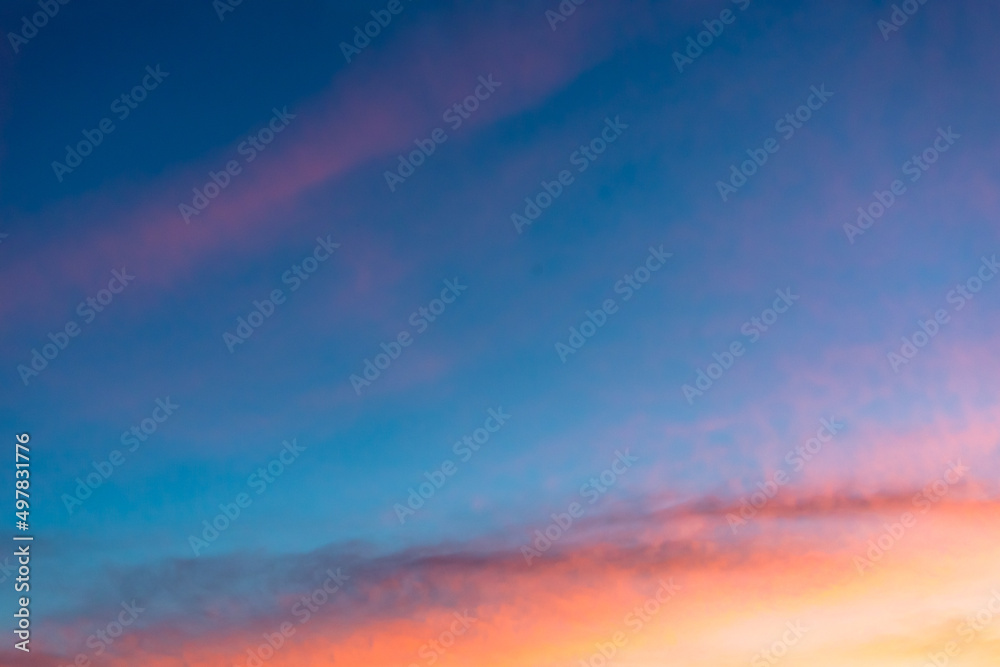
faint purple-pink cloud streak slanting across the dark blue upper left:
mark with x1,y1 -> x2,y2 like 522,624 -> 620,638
0,0 -> 641,330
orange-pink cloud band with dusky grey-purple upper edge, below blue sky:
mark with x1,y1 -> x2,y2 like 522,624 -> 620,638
25,480 -> 1000,665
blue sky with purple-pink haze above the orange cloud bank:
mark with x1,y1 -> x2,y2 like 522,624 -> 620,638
0,1 -> 1000,665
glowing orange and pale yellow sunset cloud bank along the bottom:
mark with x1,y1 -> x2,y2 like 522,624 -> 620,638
17,493 -> 1000,667
